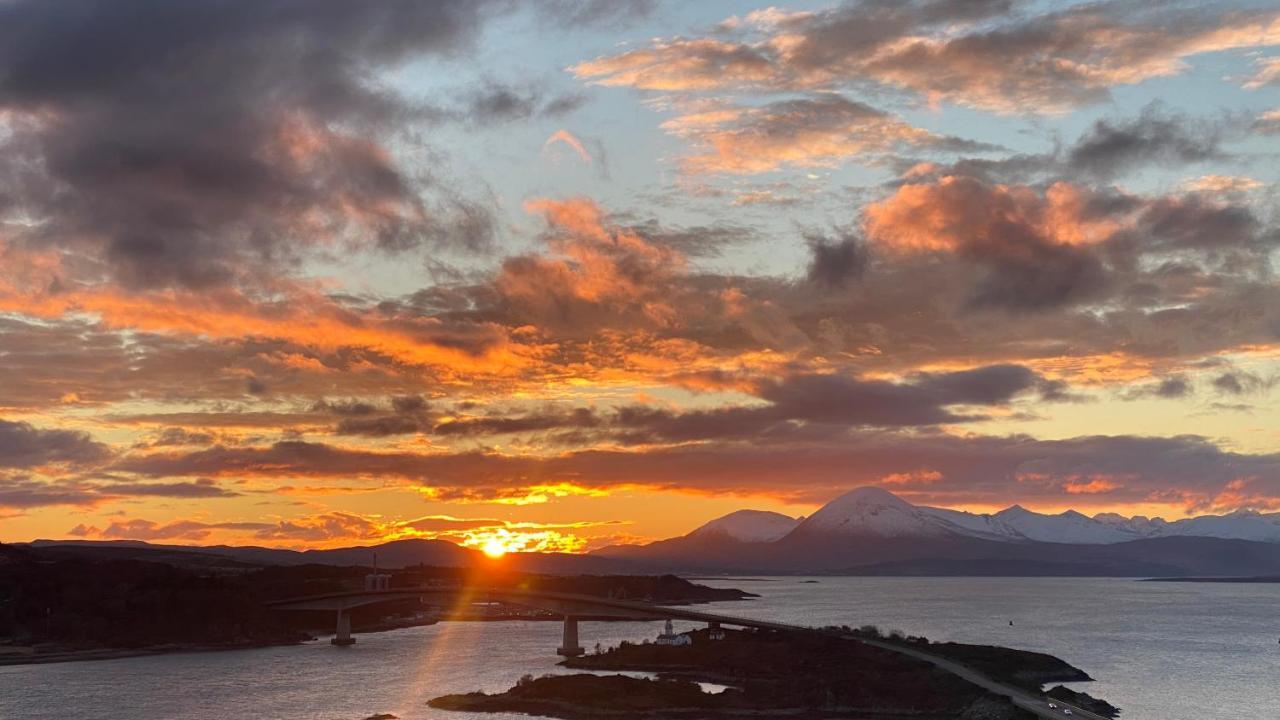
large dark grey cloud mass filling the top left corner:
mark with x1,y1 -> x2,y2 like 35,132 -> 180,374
0,0 -> 509,287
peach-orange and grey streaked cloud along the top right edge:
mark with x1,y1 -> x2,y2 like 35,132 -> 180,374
570,3 -> 1280,113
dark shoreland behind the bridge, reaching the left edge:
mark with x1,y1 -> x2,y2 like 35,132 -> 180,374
0,544 -> 749,665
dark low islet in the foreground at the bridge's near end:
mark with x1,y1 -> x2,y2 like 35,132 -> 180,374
430,630 -> 1111,720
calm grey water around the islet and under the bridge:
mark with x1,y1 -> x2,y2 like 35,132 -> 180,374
0,578 -> 1280,720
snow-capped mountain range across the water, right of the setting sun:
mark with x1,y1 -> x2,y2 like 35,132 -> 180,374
594,487 -> 1280,577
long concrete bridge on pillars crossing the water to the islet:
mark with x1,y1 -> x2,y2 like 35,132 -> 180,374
268,587 -> 813,656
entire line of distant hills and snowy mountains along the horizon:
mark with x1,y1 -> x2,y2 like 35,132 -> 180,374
22,487 -> 1280,577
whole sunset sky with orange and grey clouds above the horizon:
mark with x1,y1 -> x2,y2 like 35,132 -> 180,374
0,0 -> 1280,552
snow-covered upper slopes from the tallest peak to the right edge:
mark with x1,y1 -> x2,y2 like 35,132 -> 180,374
778,487 -> 1280,544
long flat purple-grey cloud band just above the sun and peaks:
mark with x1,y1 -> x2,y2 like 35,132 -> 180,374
104,432 -> 1280,510
